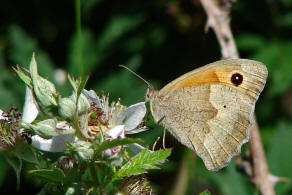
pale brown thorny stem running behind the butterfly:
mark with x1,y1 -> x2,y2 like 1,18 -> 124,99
201,0 -> 275,195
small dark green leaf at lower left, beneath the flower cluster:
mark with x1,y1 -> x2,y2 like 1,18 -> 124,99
29,168 -> 65,184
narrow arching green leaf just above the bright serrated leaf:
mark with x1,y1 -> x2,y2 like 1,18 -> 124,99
94,138 -> 145,154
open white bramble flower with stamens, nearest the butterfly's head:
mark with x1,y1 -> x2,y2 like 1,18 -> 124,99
83,90 -> 147,156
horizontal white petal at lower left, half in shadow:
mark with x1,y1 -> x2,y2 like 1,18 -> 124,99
31,135 -> 75,152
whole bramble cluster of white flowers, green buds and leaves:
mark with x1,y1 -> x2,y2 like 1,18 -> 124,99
0,55 -> 170,194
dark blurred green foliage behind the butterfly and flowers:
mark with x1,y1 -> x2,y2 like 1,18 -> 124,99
0,0 -> 292,195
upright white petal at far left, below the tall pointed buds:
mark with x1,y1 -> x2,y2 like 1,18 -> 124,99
22,86 -> 39,123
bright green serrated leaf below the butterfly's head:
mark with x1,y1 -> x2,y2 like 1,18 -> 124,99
113,149 -> 171,180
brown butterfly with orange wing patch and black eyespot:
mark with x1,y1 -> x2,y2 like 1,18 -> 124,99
146,59 -> 268,171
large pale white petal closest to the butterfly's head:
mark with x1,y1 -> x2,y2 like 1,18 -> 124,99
117,102 -> 146,134
